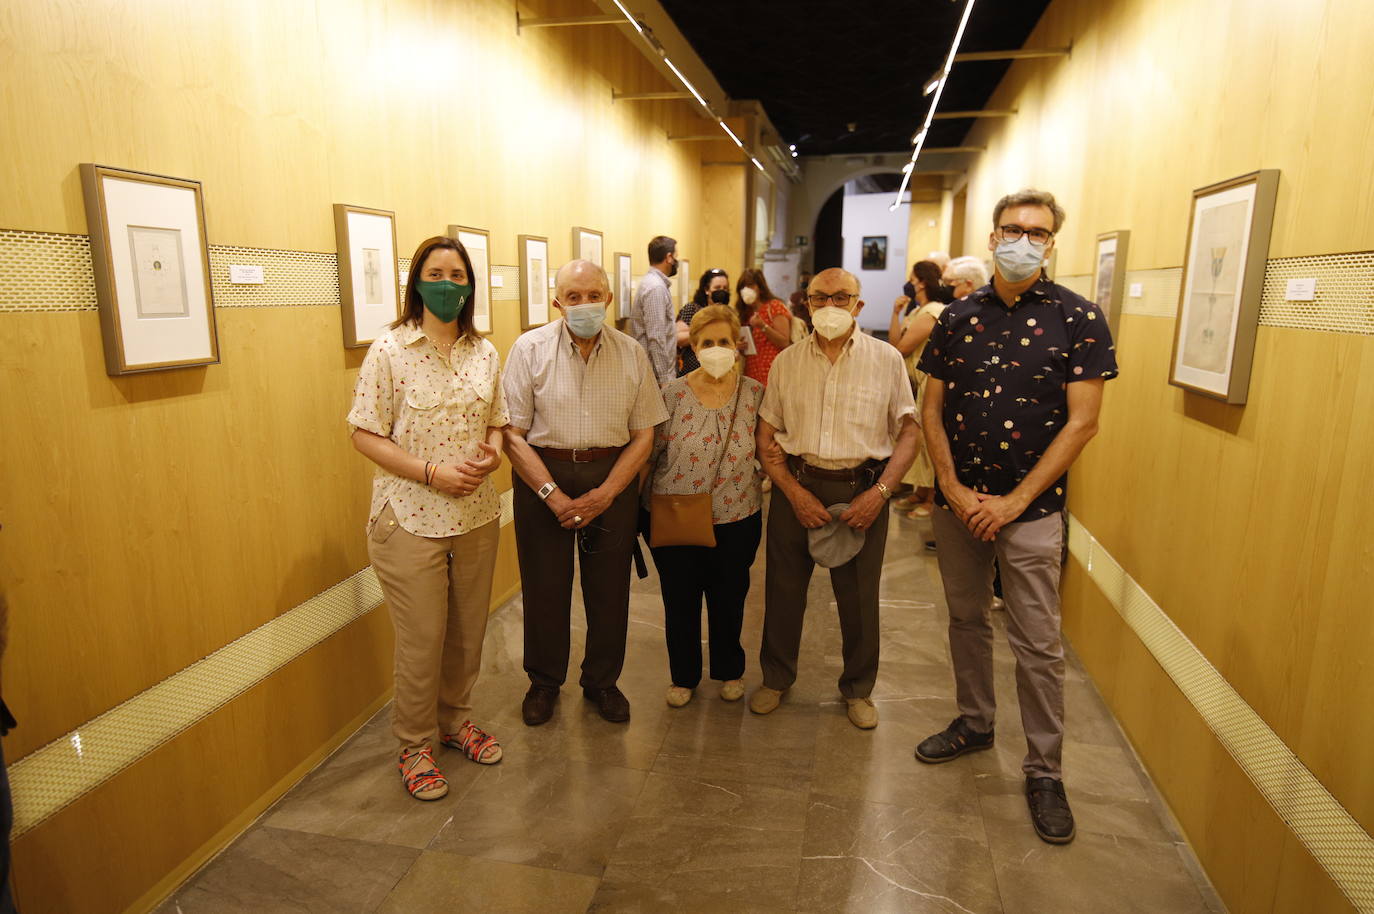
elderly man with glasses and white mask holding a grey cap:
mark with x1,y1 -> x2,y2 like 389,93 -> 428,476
749,269 -> 918,730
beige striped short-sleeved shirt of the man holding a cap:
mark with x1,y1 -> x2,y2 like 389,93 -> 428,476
758,328 -> 916,470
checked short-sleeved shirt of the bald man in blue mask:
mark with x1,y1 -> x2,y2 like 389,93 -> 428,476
504,319 -> 668,449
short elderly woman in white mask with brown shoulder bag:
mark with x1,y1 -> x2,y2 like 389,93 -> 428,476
647,305 -> 764,708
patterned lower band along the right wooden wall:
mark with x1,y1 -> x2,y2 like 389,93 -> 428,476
1069,517 -> 1374,911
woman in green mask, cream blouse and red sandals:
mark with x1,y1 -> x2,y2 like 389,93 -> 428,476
348,236 -> 508,800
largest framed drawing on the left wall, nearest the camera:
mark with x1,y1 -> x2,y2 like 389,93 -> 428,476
81,162 -> 220,375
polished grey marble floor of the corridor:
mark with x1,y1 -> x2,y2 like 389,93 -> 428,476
159,505 -> 1223,914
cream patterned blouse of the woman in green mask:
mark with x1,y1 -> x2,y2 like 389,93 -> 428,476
348,324 -> 510,536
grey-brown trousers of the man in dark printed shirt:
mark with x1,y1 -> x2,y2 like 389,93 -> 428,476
932,509 -> 1063,778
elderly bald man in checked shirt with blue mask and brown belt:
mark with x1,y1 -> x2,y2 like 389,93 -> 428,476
504,260 -> 668,727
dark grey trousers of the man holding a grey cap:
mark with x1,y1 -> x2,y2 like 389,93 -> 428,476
758,474 -> 888,698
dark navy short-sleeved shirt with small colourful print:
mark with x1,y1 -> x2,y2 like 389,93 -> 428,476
918,278 -> 1117,522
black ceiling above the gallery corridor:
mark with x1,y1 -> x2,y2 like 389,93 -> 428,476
660,0 -> 1048,155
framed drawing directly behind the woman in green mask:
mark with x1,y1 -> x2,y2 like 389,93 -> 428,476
334,203 -> 401,349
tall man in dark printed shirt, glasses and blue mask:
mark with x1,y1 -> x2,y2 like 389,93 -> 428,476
916,190 -> 1117,844
